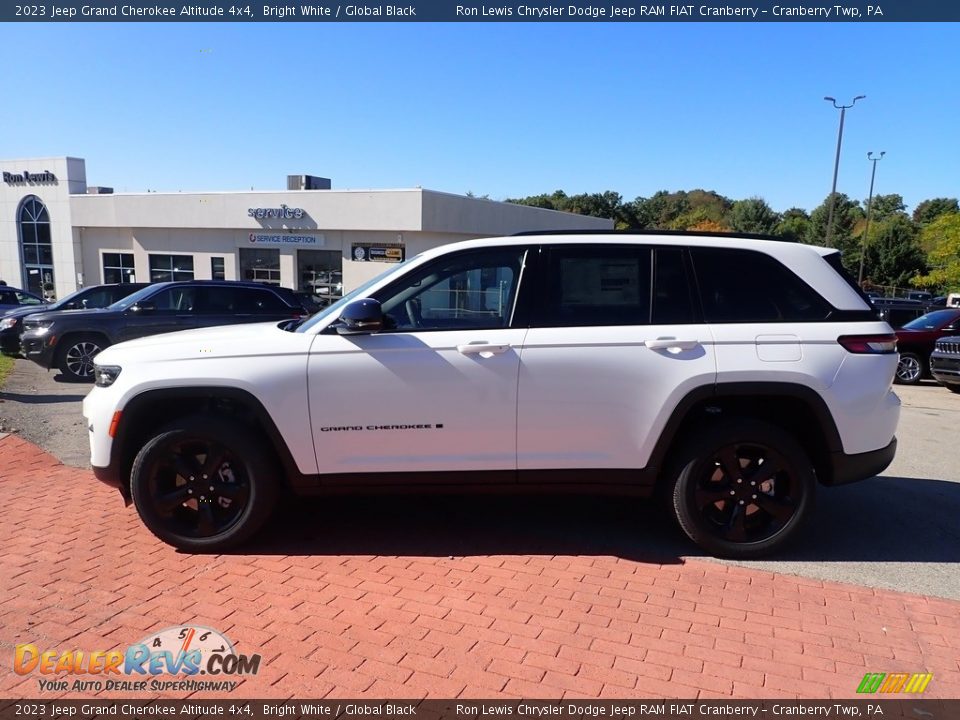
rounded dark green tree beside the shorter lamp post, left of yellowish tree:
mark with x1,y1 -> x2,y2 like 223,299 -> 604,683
860,215 -> 927,287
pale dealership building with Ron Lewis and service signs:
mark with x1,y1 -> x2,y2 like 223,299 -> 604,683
0,157 -> 613,298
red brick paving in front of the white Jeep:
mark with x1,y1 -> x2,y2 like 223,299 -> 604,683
0,436 -> 960,698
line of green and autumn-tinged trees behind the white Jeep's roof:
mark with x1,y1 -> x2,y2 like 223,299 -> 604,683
506,190 -> 960,294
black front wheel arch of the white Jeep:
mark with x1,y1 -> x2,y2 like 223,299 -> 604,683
110,386 -> 301,500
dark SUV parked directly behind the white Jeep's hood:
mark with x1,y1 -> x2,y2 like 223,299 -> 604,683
21,280 -> 309,382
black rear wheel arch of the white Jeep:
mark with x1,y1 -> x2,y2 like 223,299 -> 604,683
648,382 -> 843,485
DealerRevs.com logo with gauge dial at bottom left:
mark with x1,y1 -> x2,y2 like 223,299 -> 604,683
13,625 -> 261,692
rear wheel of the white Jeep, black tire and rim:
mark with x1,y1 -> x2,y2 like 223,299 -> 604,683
668,419 -> 817,559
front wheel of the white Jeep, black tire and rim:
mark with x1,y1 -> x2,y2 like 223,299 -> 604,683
130,415 -> 277,552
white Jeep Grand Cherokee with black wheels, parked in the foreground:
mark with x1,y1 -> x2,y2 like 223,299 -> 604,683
83,233 -> 900,557
